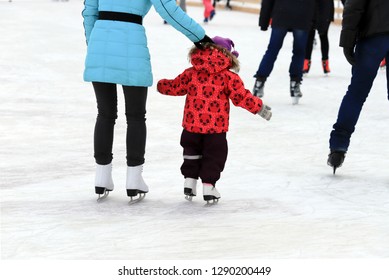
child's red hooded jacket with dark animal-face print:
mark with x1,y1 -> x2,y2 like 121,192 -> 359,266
157,48 -> 262,134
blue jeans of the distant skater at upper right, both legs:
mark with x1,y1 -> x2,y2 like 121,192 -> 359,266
255,28 -> 308,81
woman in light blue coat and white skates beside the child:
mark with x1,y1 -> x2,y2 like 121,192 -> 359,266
82,0 -> 212,199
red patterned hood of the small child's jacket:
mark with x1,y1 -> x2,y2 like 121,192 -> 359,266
190,48 -> 232,73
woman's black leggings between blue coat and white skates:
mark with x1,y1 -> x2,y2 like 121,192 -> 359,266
92,82 -> 147,166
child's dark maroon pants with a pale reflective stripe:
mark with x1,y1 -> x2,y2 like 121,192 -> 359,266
180,129 -> 228,185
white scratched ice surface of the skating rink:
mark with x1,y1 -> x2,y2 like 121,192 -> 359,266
0,0 -> 389,260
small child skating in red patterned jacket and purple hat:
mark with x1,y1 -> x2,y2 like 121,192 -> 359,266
157,37 -> 272,202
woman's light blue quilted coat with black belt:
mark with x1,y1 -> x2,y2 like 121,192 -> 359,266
82,0 -> 205,87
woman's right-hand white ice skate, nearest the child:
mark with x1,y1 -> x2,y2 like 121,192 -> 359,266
126,165 -> 149,203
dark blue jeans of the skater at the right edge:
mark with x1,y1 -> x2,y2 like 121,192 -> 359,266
330,35 -> 389,152
